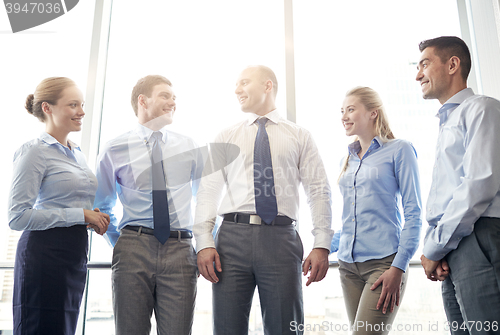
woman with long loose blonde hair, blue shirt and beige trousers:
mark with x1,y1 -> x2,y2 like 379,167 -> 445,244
332,87 -> 422,334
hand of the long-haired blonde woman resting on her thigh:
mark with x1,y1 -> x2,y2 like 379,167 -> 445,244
370,266 -> 403,314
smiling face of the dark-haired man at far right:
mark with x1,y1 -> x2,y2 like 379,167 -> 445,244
415,47 -> 454,104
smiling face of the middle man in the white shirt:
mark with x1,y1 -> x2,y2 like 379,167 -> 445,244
234,68 -> 272,115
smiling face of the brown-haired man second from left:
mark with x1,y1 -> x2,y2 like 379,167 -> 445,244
137,84 -> 176,129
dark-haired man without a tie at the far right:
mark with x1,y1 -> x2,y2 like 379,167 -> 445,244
416,37 -> 500,334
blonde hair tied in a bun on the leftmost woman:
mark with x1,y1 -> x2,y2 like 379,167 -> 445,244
24,77 -> 76,122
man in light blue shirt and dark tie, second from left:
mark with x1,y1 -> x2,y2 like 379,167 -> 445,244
95,76 -> 203,335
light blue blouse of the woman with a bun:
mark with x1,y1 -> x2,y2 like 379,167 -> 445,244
9,133 -> 97,230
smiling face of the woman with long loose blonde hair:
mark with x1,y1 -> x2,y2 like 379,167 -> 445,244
341,95 -> 377,140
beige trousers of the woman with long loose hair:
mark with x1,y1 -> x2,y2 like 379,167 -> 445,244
339,254 -> 408,335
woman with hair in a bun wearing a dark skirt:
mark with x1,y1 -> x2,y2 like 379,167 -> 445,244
9,77 -> 109,335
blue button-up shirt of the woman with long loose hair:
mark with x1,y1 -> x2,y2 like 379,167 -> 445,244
334,136 -> 422,271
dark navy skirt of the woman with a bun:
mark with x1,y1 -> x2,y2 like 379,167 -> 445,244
13,225 -> 88,335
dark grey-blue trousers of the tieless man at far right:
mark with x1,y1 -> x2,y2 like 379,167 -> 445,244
442,218 -> 500,335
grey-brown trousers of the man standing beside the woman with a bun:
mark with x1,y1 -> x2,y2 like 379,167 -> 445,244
111,229 -> 198,335
